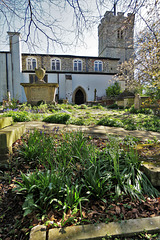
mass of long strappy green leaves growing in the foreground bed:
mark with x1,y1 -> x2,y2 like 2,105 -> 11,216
14,129 -> 158,220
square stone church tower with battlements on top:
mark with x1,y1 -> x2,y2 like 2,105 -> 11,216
98,11 -> 134,63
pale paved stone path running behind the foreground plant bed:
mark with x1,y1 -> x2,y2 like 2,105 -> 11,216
25,121 -> 160,141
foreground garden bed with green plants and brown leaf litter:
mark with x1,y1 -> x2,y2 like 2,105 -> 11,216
0,128 -> 160,240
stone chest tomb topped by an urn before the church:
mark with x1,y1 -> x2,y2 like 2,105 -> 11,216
21,68 -> 58,105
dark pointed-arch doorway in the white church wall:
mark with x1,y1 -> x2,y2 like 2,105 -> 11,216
72,86 -> 87,105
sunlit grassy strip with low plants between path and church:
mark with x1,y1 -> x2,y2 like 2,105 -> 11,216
3,104 -> 160,132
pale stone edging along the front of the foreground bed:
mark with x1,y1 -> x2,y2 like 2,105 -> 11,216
30,216 -> 160,240
